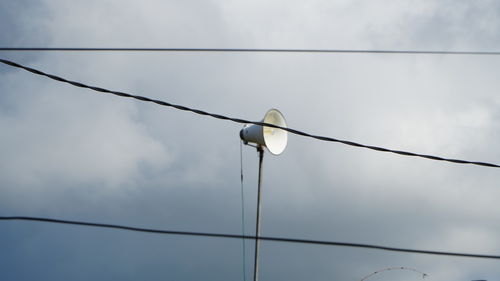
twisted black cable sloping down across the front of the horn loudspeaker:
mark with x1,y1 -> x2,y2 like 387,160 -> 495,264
0,56 -> 500,168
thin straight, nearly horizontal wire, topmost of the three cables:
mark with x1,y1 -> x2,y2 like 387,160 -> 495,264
0,47 -> 500,56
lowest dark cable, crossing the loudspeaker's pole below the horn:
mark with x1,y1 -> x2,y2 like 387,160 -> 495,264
0,216 -> 500,260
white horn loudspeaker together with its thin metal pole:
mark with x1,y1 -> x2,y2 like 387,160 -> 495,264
240,109 -> 288,281
